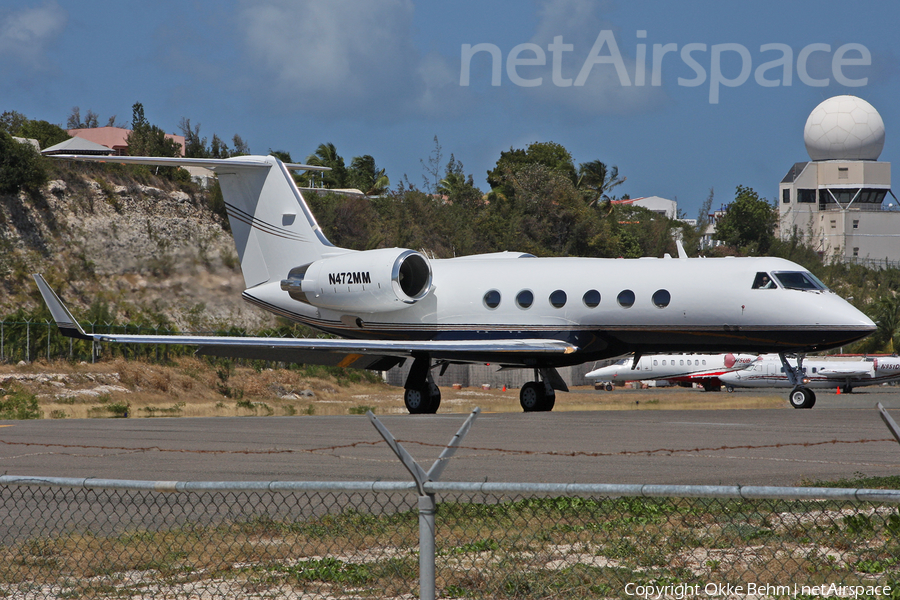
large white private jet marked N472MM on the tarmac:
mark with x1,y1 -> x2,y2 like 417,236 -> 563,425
35,156 -> 875,413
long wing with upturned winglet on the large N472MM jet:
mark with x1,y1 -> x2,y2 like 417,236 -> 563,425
34,274 -> 577,370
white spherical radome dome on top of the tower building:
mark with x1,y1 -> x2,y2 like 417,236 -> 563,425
803,96 -> 884,160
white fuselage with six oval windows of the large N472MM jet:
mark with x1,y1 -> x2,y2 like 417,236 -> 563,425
244,253 -> 874,364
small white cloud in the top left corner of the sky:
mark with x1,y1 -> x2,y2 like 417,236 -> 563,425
0,1 -> 69,69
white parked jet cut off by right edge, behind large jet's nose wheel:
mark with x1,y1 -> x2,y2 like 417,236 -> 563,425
719,354 -> 900,408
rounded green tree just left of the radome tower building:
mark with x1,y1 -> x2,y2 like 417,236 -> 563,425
716,185 -> 778,254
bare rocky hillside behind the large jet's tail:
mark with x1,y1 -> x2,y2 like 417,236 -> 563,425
0,161 -> 273,330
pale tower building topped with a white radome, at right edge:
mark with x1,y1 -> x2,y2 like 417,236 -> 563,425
778,96 -> 900,265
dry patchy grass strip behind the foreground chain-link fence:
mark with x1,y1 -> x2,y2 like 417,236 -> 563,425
0,495 -> 900,599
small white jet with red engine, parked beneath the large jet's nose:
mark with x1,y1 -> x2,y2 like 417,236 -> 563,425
585,353 -> 758,392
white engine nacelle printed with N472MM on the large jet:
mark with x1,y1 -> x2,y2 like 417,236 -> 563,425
281,248 -> 432,313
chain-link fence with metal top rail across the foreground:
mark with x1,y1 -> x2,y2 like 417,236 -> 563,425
0,476 -> 900,600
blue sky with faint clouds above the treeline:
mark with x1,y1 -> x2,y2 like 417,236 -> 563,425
0,0 -> 900,217
